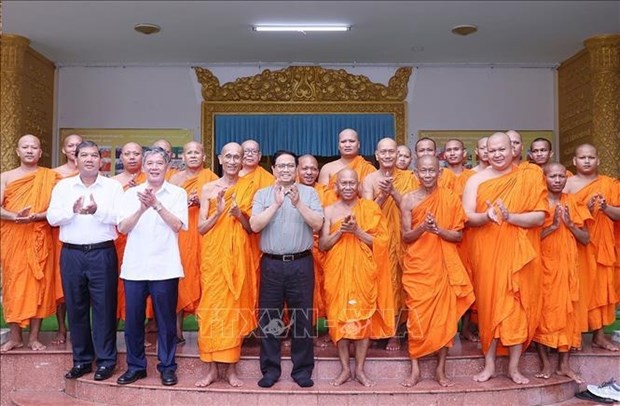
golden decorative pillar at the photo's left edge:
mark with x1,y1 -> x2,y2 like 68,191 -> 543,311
0,34 -> 56,172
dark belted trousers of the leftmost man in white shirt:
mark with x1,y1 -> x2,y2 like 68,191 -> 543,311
60,246 -> 118,367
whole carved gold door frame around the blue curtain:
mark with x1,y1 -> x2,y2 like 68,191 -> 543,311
194,66 -> 411,167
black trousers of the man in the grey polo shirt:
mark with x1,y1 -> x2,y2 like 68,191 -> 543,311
259,255 -> 314,379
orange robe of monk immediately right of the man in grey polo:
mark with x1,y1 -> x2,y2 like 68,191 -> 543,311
325,199 -> 395,343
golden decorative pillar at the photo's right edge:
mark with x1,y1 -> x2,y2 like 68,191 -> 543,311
584,34 -> 620,178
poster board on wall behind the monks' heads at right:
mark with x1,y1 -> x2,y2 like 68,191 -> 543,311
418,130 -> 557,168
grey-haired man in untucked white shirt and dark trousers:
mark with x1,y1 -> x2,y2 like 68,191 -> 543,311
117,147 -> 188,386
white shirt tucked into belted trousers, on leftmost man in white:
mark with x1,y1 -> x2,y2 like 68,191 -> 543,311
47,175 -> 123,244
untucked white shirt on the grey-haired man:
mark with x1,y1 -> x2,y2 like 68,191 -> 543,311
117,182 -> 188,281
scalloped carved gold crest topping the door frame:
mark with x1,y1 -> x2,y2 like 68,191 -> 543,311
194,66 -> 411,102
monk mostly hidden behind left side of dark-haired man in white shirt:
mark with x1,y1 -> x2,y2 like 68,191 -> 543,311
52,134 -> 82,344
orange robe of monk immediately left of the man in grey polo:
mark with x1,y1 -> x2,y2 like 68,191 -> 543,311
196,178 -> 257,363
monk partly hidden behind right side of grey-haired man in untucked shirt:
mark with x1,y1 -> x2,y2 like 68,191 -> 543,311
170,141 -> 217,344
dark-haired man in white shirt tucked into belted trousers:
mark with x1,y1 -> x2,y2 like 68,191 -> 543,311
47,141 -> 123,381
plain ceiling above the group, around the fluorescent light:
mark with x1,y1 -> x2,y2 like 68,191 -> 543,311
2,0 -> 620,66
